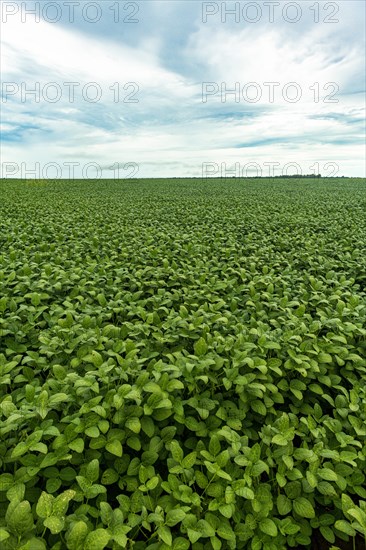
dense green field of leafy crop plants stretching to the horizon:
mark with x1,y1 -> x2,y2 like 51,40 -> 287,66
0,179 -> 366,550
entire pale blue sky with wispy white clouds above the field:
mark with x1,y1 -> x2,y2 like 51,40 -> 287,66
1,0 -> 366,178
